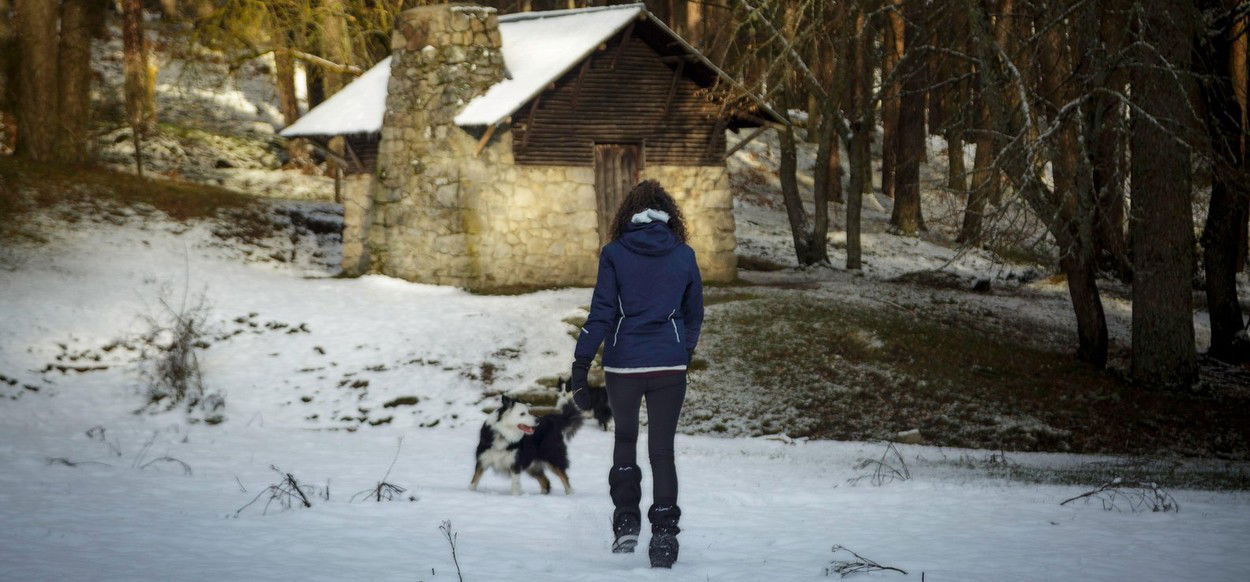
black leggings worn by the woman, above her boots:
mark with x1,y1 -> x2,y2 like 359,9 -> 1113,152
606,372 -> 686,505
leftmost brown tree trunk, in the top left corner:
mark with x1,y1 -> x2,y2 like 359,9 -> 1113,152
14,0 -> 60,161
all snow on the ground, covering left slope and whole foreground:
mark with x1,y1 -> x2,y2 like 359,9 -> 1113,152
0,201 -> 1250,581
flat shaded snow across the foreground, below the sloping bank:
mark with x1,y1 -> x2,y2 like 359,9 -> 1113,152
0,418 -> 1250,581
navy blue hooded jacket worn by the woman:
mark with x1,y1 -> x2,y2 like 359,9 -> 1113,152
574,216 -> 703,370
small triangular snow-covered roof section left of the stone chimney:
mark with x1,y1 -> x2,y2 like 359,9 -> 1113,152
280,56 -> 391,137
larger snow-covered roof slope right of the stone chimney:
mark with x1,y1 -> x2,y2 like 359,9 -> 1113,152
455,4 -> 645,125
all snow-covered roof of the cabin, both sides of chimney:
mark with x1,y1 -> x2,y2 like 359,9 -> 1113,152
280,4 -> 771,137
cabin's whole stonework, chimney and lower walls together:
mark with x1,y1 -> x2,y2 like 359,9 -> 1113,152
344,5 -> 736,290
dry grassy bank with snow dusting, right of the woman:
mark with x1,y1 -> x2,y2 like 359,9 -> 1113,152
686,291 -> 1250,460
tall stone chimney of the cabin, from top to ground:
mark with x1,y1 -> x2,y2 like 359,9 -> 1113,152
365,4 -> 504,285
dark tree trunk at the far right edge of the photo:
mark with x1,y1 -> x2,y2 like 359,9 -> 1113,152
1195,0 -> 1250,362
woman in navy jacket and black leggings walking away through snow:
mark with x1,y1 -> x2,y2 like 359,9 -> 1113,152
569,180 -> 703,568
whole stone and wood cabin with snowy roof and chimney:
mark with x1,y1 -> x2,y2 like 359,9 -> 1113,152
281,4 -> 780,290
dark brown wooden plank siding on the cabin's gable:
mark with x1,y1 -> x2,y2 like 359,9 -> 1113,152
513,32 -> 725,166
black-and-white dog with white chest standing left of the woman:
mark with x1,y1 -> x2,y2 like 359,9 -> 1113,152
469,383 -> 583,495
